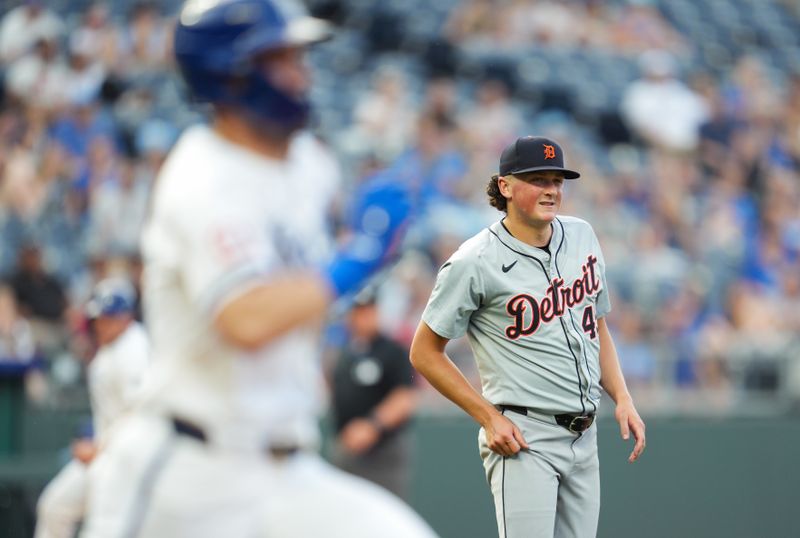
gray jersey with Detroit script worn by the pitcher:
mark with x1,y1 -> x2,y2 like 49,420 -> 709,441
422,216 -> 611,414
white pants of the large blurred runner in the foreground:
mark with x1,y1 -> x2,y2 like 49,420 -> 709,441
82,417 -> 435,538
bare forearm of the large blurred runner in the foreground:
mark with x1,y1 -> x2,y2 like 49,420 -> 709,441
215,273 -> 333,350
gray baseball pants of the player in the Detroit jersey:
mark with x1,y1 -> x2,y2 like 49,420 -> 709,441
478,411 -> 600,538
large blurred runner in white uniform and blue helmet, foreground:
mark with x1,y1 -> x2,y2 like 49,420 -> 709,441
84,0 -> 434,538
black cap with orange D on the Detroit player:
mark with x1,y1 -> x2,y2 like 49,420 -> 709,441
500,136 -> 581,179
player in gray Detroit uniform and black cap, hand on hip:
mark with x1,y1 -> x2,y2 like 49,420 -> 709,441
411,137 -> 645,538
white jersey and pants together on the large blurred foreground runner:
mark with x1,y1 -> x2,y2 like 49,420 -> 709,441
83,127 -> 434,538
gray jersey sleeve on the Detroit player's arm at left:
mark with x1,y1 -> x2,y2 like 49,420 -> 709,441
422,252 -> 484,340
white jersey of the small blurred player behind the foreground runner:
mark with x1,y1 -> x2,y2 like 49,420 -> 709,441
88,321 -> 150,446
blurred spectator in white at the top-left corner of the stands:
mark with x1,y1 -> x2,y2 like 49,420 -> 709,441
0,0 -> 64,64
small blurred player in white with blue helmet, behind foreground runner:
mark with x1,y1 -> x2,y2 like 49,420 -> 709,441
35,279 -> 149,538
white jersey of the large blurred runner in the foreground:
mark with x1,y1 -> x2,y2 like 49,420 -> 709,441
143,126 -> 339,447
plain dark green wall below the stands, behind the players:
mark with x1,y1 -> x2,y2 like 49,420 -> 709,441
0,413 -> 800,538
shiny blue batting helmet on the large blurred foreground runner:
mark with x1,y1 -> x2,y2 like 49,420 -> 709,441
174,0 -> 329,131
